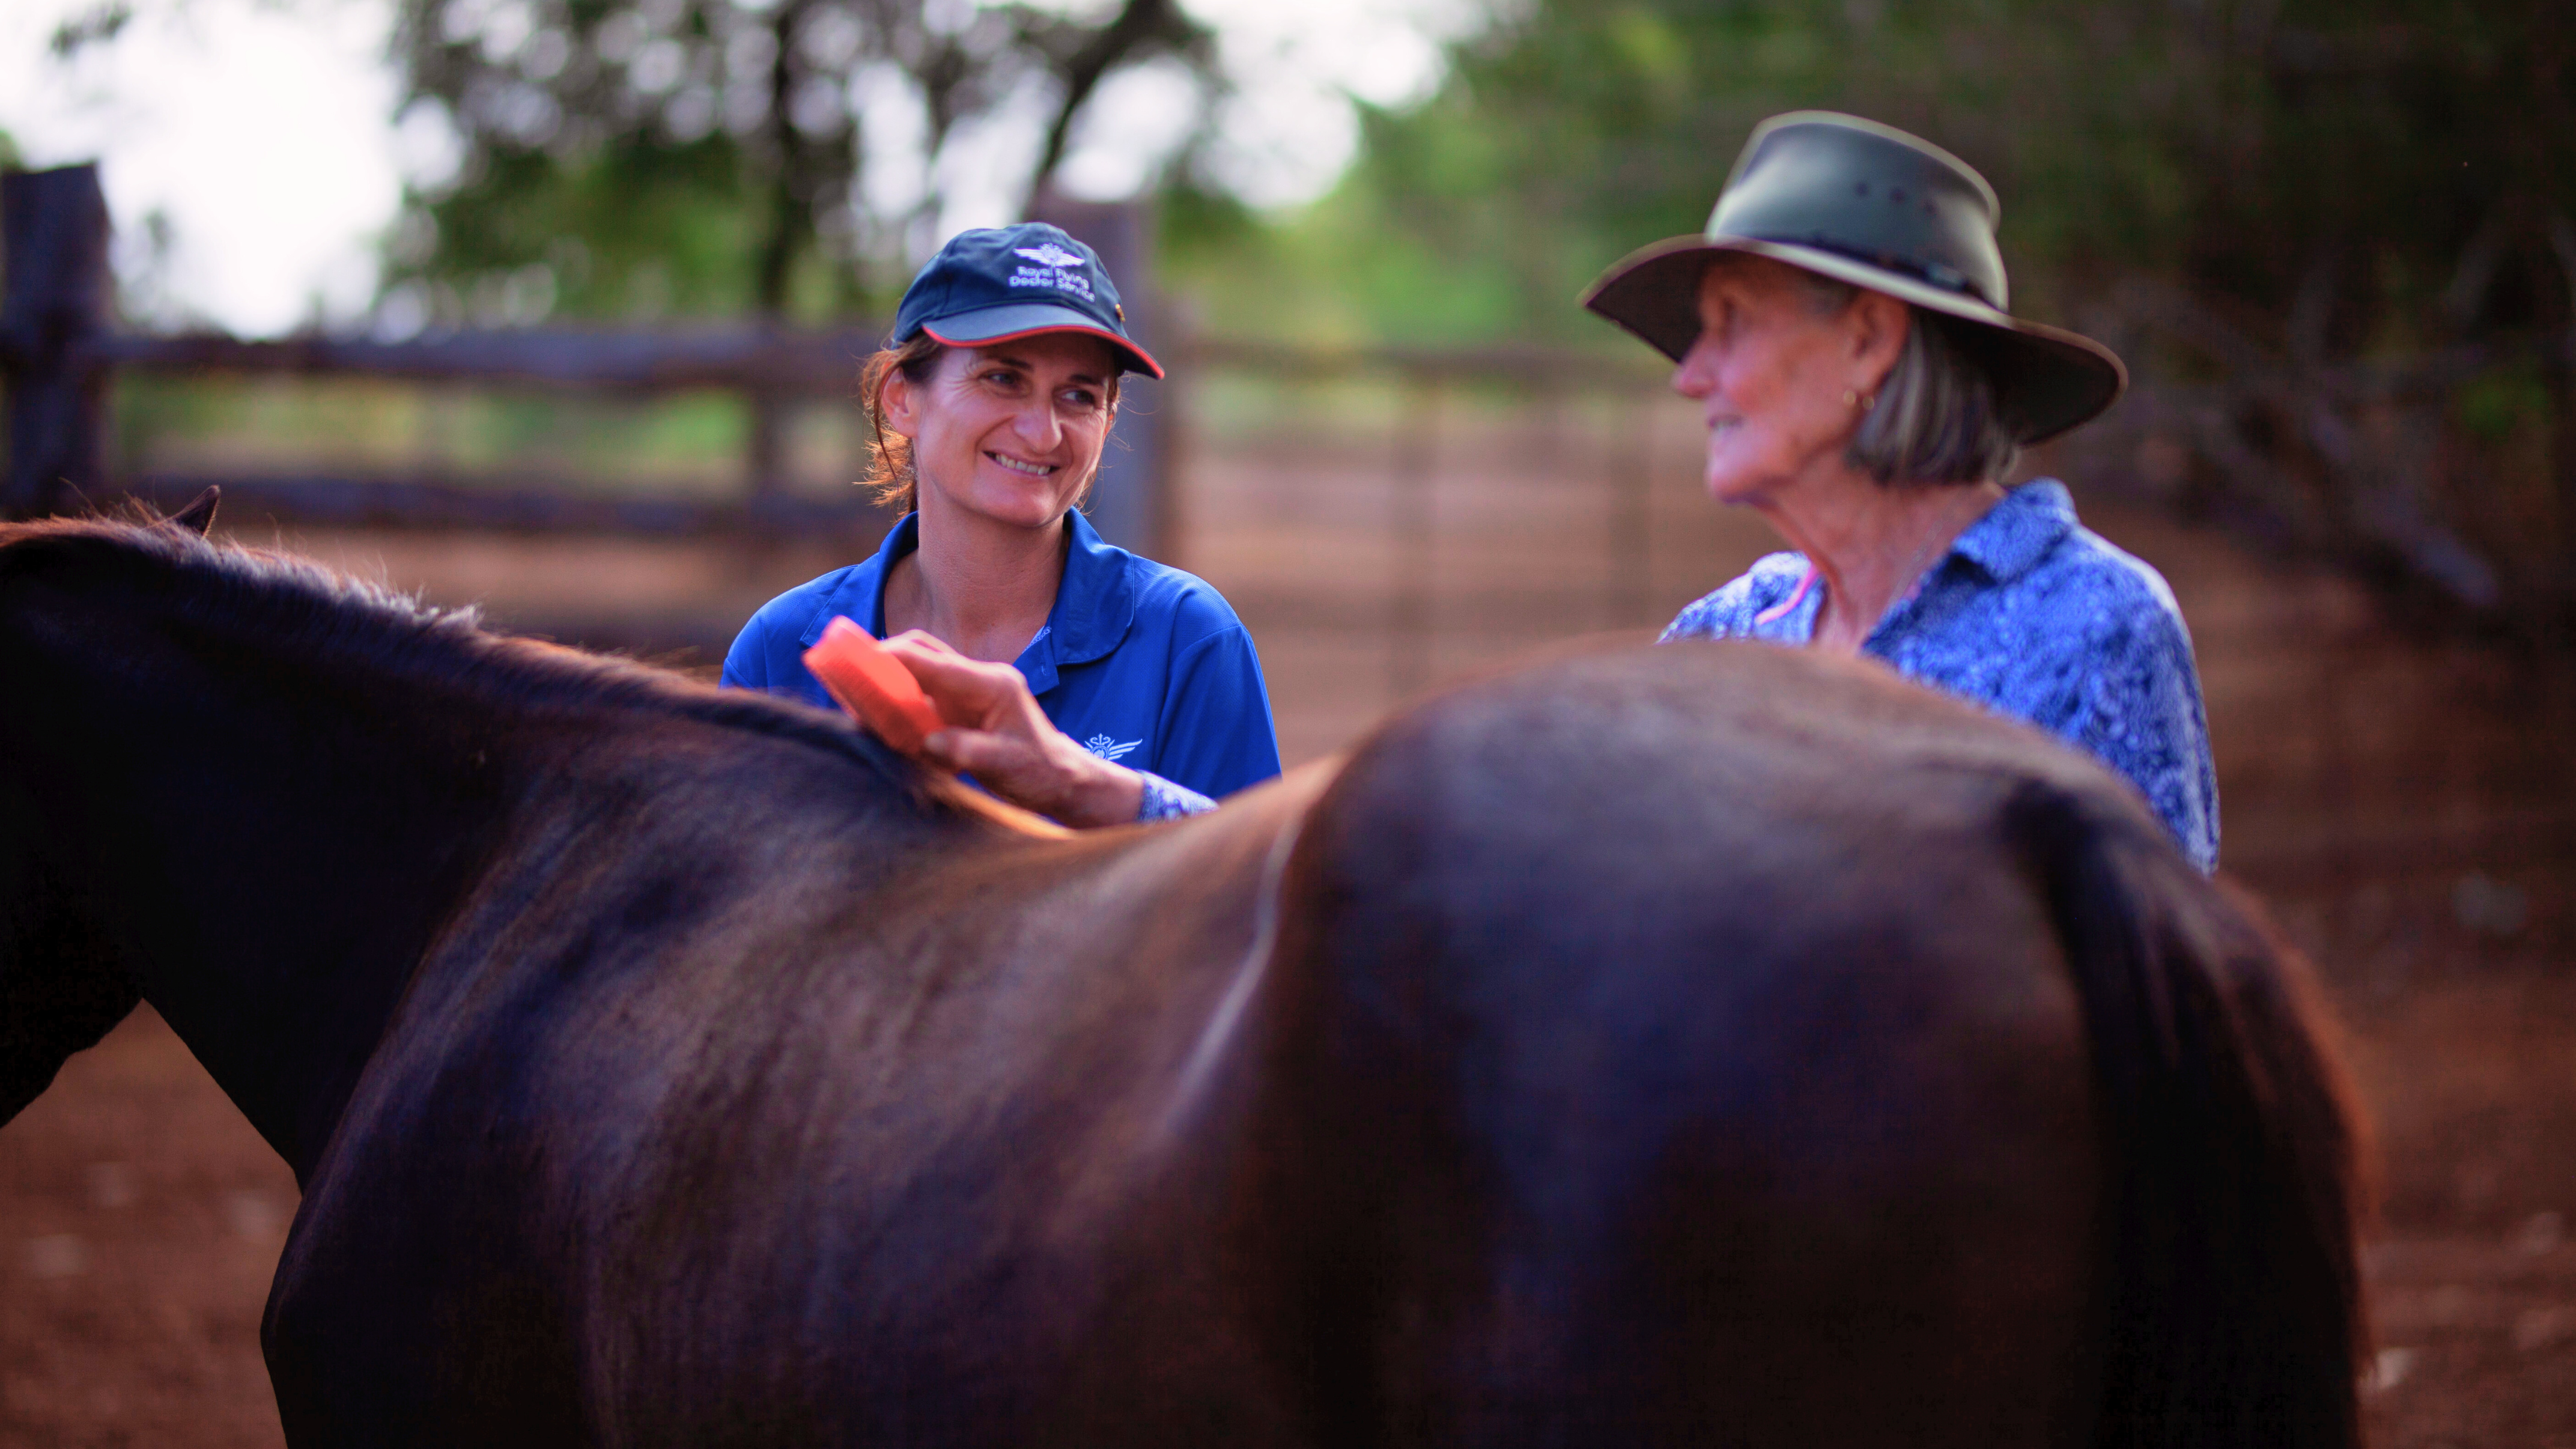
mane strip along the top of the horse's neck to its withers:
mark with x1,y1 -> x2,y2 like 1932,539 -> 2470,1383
0,505 -> 1062,836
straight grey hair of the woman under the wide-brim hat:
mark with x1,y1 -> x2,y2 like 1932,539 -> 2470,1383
1796,268 -> 2022,485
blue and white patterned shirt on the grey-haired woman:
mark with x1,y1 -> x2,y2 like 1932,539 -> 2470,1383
1664,477 -> 2218,872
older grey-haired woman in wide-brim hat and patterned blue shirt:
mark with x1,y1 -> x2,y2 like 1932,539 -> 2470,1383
1584,111 -> 2218,869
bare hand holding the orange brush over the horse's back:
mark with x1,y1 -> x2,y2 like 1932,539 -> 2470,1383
886,629 -> 1144,828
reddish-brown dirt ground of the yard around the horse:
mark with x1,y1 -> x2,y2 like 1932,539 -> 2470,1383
0,389 -> 2576,1449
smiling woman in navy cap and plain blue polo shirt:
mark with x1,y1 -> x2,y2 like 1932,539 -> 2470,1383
724,224 -> 1280,825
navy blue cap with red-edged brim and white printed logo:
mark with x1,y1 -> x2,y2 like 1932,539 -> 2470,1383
894,222 -> 1162,377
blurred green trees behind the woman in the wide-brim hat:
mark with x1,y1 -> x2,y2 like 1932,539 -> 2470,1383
1167,0 -> 2576,627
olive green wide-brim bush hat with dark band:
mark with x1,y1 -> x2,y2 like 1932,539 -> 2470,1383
1584,111 -> 2128,443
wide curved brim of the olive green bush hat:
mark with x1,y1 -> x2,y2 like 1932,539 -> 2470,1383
1582,237 -> 2128,443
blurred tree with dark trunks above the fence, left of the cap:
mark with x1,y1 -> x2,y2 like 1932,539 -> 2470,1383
386,0 -> 1214,325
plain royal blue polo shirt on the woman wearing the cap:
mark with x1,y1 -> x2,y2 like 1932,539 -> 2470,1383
724,513 -> 1280,818
